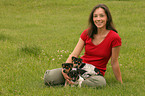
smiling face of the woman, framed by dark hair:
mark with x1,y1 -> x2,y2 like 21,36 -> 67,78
93,8 -> 107,29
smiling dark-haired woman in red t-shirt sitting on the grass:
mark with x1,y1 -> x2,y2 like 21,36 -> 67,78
44,4 -> 122,87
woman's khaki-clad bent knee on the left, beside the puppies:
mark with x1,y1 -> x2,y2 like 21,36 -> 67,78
44,68 -> 65,86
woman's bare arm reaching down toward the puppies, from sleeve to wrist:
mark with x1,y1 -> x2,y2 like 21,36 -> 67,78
66,38 -> 85,63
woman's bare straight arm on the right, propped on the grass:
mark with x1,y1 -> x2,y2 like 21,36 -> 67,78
111,46 -> 123,83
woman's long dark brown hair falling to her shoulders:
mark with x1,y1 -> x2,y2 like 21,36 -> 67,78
88,4 -> 117,39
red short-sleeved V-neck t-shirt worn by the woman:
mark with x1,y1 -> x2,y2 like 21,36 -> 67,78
80,29 -> 121,76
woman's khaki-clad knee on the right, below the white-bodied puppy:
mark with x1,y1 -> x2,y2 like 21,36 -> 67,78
82,76 -> 106,87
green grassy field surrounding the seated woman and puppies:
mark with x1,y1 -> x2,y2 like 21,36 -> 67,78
0,0 -> 145,96
